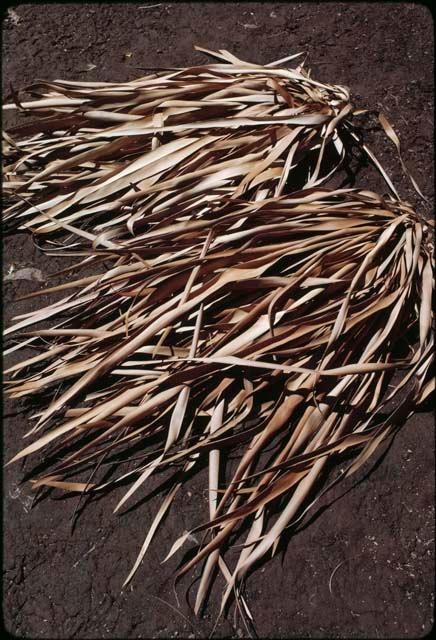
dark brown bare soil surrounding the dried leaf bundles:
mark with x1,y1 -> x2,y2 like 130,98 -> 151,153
3,0 -> 434,638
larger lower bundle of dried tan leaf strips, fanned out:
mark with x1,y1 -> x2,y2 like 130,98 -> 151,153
3,187 -> 434,611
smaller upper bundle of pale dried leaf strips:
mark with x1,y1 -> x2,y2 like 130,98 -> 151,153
3,49 -> 364,248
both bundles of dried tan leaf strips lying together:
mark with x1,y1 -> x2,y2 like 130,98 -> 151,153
4,47 -> 433,624
